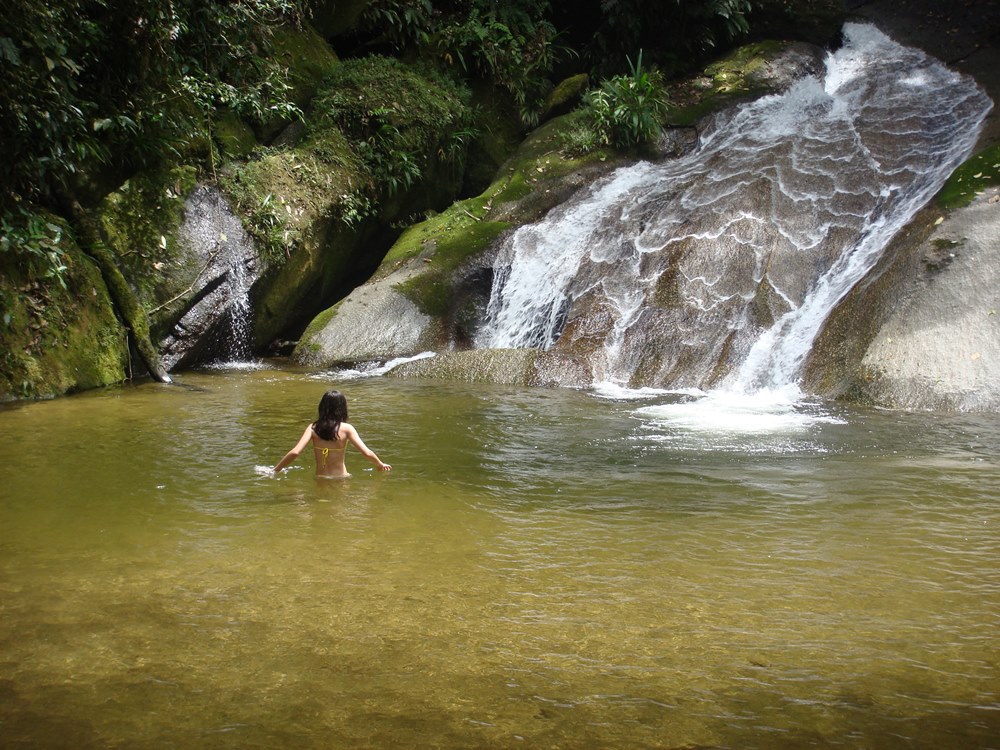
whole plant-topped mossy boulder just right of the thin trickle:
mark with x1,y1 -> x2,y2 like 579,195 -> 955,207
220,58 -> 480,345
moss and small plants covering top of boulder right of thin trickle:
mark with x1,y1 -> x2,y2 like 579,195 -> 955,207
226,57 -> 469,244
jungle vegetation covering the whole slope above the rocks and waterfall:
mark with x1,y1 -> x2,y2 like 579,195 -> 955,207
0,0 -> 832,396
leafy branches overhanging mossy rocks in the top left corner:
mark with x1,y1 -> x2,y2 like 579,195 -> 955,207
0,0 -> 304,207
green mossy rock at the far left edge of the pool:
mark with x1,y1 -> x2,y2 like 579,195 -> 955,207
0,217 -> 129,401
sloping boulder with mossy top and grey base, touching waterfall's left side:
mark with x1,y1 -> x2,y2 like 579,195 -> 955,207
293,110 -> 622,366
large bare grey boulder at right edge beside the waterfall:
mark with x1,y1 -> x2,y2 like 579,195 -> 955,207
806,147 -> 1000,412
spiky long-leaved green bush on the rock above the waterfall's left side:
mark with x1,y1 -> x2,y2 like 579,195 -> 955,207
585,50 -> 667,149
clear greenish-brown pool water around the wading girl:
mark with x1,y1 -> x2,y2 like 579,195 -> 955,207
0,369 -> 1000,749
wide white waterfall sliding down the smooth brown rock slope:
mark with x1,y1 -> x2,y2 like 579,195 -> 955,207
477,24 -> 992,390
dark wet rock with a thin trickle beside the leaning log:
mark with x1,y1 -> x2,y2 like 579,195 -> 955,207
160,185 -> 262,369
